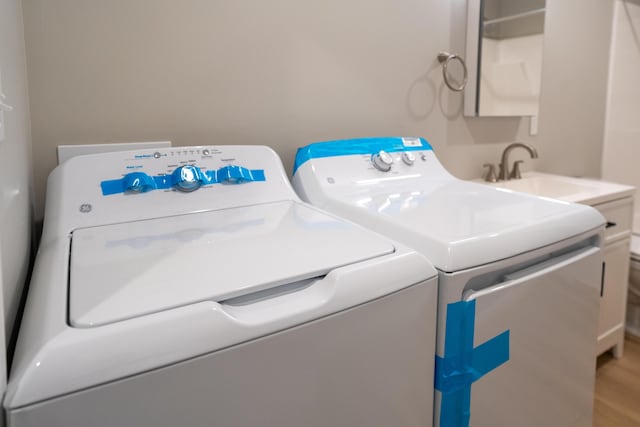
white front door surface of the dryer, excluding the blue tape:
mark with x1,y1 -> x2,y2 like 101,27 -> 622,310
464,247 -> 602,427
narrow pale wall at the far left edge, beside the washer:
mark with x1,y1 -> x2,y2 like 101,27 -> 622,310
0,0 -> 32,384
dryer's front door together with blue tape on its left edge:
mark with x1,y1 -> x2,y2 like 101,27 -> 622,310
436,247 -> 602,426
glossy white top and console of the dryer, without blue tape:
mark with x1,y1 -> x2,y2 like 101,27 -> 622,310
293,150 -> 604,272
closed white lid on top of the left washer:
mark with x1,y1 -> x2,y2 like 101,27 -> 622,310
69,201 -> 394,327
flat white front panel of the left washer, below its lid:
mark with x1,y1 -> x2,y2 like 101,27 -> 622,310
7,279 -> 436,427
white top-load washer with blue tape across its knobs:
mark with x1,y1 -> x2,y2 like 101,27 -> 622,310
4,146 -> 437,427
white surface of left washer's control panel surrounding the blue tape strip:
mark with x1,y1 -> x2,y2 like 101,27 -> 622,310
42,145 -> 297,243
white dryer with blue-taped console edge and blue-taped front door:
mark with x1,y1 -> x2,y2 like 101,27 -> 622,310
293,138 -> 604,427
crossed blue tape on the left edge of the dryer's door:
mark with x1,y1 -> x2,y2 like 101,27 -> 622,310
435,300 -> 509,427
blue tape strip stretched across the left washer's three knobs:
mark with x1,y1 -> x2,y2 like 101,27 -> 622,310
100,166 -> 265,196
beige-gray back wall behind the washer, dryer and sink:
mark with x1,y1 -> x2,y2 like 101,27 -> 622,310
24,0 -> 612,216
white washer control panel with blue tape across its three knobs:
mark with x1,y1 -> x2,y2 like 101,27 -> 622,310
46,145 -> 299,232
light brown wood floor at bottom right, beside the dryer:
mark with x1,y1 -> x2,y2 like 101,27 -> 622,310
593,337 -> 640,427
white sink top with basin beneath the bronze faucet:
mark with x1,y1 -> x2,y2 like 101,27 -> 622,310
476,172 -> 634,205
